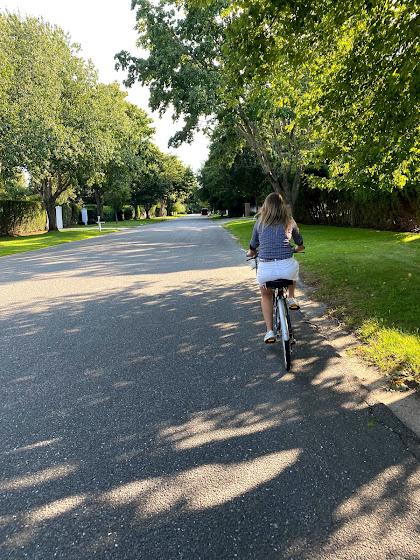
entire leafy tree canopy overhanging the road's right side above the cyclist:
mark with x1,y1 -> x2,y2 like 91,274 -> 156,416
118,0 -> 420,204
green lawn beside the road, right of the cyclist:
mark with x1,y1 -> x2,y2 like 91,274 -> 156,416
226,220 -> 420,388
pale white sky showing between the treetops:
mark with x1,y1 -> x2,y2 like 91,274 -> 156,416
0,0 -> 208,171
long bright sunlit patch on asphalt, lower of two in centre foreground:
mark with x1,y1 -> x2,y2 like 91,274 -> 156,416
101,449 -> 301,521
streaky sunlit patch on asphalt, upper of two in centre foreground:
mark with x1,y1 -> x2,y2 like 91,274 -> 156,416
158,401 -> 301,451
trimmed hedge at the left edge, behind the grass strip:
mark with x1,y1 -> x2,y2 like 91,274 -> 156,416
0,200 -> 47,235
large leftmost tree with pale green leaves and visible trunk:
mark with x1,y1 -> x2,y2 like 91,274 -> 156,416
0,15 -> 96,229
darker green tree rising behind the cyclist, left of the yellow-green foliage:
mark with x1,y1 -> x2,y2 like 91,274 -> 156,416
117,0 -> 308,208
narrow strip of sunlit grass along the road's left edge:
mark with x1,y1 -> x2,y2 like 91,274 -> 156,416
0,229 -> 116,257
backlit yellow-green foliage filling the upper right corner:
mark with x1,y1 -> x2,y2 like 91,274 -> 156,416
197,0 -> 420,189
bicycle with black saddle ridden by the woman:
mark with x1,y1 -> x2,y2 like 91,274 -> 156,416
247,251 -> 302,371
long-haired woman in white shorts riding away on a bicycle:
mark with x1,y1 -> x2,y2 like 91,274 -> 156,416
247,193 -> 305,342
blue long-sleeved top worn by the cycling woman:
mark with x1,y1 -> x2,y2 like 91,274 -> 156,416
249,218 -> 303,259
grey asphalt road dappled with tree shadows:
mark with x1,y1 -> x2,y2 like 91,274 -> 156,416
0,216 -> 420,560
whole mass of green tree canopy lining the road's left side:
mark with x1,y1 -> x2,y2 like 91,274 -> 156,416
0,13 -> 189,229
